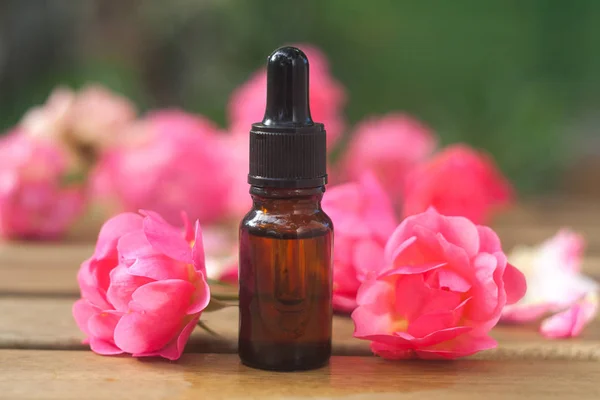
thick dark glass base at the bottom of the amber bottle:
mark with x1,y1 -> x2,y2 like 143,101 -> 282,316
238,340 -> 331,372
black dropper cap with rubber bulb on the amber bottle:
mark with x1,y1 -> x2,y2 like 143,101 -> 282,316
248,47 -> 327,188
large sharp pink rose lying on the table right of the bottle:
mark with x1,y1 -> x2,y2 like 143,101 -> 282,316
352,209 -> 526,359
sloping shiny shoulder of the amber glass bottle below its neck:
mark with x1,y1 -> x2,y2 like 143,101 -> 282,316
240,209 -> 333,237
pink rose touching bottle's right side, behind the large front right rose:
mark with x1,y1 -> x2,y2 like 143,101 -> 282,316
322,173 -> 398,312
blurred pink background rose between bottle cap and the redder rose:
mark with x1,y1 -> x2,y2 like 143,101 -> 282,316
341,113 -> 437,201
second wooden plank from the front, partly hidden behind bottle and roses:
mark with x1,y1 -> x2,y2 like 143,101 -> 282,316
0,297 -> 600,361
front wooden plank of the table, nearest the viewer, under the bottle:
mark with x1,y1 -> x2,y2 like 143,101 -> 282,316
0,350 -> 600,400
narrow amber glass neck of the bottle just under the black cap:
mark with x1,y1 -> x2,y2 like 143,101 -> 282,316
250,186 -> 325,213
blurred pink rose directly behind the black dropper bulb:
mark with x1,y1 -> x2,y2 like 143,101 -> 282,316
228,44 -> 346,148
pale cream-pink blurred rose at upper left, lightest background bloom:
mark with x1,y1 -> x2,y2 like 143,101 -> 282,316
21,84 -> 137,151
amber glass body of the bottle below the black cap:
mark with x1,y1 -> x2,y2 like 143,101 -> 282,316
238,186 -> 333,371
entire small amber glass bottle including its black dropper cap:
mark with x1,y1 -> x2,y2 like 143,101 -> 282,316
238,47 -> 333,371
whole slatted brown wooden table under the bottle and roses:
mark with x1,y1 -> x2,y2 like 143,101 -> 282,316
0,200 -> 600,400
